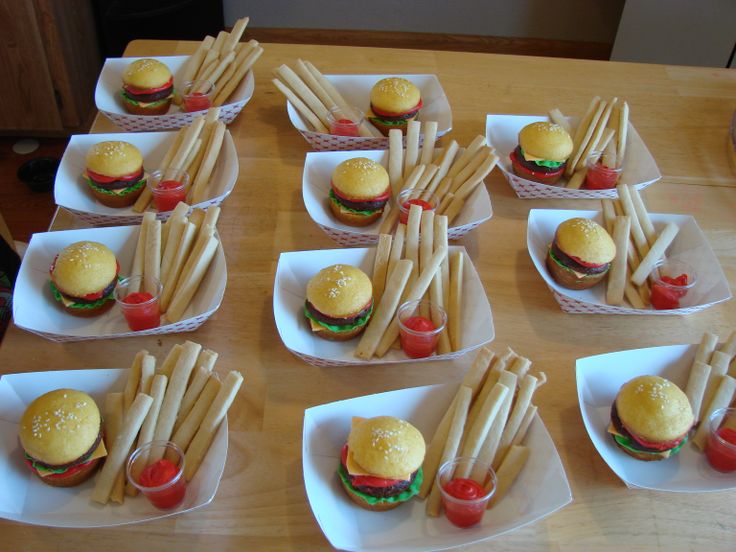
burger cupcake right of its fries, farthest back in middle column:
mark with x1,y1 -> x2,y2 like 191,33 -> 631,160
366,77 -> 422,136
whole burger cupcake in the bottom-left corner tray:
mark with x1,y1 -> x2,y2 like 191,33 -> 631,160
18,389 -> 107,487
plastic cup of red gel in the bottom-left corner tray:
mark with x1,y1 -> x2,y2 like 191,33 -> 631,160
125,441 -> 187,510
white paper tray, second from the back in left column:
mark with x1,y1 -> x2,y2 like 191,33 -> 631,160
54,130 -> 239,226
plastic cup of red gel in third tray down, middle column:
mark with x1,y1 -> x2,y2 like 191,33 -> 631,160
398,300 -> 447,358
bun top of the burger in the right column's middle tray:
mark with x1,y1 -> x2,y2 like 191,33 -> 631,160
555,218 -> 616,264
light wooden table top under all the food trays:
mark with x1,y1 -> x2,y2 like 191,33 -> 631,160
0,41 -> 736,551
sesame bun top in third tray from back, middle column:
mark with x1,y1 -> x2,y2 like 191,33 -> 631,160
307,264 -> 373,318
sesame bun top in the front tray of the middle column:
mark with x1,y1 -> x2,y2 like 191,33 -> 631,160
348,416 -> 425,479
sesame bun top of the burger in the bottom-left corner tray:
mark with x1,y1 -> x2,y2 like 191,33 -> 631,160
18,389 -> 101,466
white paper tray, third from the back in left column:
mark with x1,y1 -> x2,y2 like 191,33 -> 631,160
13,226 -> 227,342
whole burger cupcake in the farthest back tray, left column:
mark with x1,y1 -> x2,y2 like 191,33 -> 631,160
120,58 -> 174,115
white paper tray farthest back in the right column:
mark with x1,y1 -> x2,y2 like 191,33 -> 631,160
486,115 -> 662,199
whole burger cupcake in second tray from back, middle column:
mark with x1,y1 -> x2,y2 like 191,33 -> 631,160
328,157 -> 391,226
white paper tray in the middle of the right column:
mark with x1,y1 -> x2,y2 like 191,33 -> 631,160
526,209 -> 731,316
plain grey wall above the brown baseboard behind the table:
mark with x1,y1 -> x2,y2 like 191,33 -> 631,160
223,0 -> 620,43
